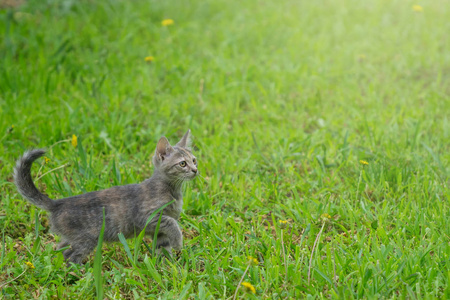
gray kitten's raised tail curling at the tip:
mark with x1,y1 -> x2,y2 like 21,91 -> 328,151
14,149 -> 55,210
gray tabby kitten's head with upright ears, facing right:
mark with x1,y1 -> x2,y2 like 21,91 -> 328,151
153,130 -> 198,183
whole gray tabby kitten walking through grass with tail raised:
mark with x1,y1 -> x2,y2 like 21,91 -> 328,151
14,130 -> 197,264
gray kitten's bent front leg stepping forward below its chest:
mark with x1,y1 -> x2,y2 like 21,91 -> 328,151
147,216 -> 183,253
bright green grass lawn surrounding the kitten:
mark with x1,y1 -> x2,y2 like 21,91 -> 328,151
0,0 -> 450,299
